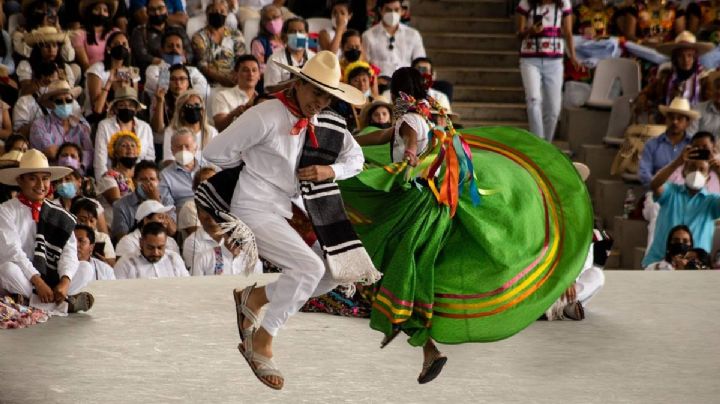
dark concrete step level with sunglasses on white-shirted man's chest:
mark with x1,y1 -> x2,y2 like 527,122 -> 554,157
422,31 -> 520,51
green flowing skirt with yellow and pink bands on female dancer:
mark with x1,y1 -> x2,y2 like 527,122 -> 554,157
340,127 -> 593,346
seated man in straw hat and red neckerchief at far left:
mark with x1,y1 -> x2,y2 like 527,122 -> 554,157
0,149 -> 94,313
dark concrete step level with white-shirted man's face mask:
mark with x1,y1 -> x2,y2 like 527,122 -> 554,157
412,16 -> 515,34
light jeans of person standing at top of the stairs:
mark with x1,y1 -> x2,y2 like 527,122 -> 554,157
520,58 -> 563,142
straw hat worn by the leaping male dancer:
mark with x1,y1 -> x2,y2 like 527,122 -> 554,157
273,51 -> 365,105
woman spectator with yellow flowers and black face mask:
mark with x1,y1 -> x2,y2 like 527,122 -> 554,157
95,132 -> 141,223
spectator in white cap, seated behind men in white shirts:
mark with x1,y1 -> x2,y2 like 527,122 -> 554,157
115,200 -> 180,257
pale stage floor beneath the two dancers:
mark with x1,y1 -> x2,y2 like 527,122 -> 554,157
0,271 -> 720,403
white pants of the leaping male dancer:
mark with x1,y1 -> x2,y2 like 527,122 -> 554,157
233,209 -> 337,336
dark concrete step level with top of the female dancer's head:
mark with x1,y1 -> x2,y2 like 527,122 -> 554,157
435,66 -> 522,87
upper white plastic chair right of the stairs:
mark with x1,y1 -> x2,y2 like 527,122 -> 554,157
586,58 -> 640,108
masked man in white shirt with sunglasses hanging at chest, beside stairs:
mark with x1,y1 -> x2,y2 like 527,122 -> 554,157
363,0 -> 425,77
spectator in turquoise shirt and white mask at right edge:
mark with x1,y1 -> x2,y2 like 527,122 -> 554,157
642,153 -> 720,267
